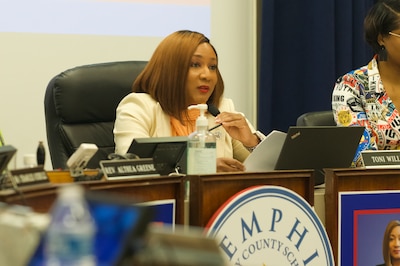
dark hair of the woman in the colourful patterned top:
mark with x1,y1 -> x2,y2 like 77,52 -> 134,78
364,0 -> 400,53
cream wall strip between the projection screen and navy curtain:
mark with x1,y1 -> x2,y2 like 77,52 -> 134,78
211,0 -> 258,126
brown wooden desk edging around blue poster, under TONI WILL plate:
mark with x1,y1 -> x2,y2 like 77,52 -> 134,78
325,168 -> 400,265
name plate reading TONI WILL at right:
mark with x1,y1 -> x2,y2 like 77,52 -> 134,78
361,150 -> 400,168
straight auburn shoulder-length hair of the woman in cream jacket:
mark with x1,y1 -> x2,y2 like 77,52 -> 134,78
132,30 -> 224,122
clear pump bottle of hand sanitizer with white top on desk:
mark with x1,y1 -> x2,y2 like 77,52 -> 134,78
187,104 -> 217,175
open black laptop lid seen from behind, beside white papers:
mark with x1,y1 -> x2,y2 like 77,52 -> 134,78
275,126 -> 365,185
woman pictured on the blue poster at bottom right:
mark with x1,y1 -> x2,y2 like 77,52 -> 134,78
377,220 -> 400,266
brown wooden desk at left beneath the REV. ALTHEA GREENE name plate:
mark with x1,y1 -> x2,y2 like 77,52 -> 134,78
0,172 -> 184,224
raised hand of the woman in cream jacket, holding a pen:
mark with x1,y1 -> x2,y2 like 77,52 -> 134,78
215,112 -> 260,147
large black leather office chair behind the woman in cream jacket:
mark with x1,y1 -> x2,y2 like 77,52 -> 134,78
44,61 -> 147,169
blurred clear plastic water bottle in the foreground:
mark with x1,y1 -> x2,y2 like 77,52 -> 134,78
44,184 -> 96,266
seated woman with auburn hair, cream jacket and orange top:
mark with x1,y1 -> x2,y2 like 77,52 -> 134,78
114,30 -> 265,172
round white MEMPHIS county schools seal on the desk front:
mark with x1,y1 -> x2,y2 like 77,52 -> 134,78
207,186 -> 334,266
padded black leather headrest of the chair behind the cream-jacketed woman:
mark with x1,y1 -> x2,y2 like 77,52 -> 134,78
49,61 -> 147,124
